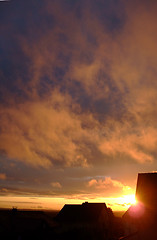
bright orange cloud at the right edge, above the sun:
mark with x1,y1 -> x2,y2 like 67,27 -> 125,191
99,123 -> 154,163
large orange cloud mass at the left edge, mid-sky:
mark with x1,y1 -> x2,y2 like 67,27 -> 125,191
0,91 -> 99,168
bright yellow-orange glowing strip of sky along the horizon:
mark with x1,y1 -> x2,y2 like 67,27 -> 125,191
0,194 -> 136,211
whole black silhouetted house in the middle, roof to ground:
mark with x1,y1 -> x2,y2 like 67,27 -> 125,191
55,202 -> 114,239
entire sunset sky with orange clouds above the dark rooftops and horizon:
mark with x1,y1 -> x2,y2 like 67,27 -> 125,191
0,0 -> 157,210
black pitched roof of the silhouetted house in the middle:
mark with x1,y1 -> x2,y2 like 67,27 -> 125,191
56,202 -> 107,222
